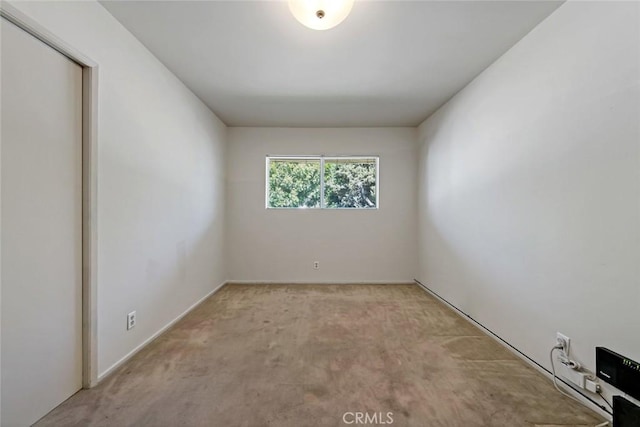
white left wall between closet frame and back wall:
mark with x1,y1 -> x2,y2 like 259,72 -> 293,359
5,1 -> 226,380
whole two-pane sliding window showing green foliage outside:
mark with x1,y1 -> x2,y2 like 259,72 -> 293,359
266,156 -> 379,209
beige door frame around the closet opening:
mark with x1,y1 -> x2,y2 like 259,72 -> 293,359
0,1 -> 98,388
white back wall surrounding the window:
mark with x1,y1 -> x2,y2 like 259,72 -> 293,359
227,128 -> 417,282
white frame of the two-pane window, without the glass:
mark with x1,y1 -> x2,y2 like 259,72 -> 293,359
264,155 -> 380,211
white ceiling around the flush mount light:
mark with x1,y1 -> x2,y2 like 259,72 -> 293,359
102,0 -> 562,127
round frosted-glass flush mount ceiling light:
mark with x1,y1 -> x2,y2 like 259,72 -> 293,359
289,0 -> 354,30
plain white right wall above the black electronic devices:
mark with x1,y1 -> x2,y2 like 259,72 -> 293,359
418,2 -> 640,402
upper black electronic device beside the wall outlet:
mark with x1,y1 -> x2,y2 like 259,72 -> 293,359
596,347 -> 640,399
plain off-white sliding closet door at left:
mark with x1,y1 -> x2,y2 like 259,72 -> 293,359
0,19 -> 82,427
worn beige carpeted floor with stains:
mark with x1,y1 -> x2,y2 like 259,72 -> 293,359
37,285 -> 602,427
